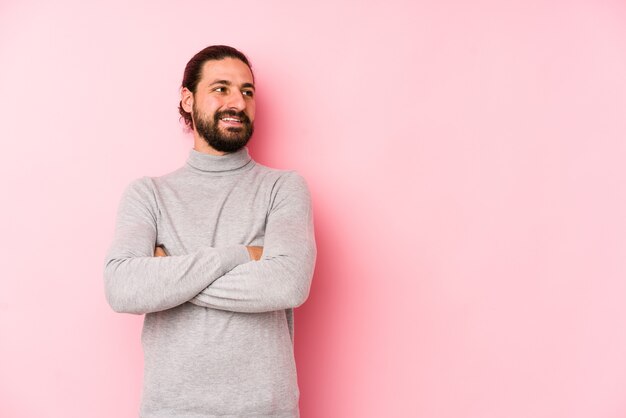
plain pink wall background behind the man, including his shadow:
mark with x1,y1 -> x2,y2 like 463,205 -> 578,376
0,0 -> 626,418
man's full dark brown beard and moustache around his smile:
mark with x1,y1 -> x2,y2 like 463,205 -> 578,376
192,103 -> 254,152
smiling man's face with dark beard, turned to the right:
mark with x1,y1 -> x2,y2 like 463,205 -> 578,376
191,58 -> 255,152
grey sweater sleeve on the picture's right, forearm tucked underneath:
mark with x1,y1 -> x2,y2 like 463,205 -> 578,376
190,172 -> 317,312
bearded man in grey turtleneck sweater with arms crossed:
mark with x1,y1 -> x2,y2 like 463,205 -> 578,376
104,46 -> 316,418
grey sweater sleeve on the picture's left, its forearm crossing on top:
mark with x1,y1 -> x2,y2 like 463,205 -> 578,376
104,178 -> 250,314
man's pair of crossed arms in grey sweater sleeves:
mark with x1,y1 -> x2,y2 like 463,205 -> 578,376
105,173 -> 316,314
